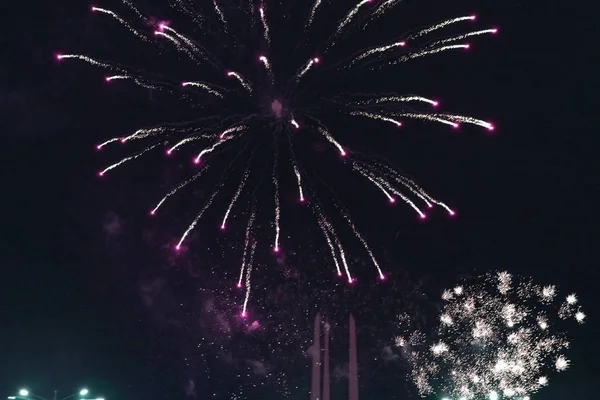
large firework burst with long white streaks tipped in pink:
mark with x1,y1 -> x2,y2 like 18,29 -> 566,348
56,0 -> 496,315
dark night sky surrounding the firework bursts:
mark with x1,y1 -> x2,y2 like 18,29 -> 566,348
0,0 -> 600,400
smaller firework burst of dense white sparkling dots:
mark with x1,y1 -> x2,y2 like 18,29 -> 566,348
396,272 -> 585,400
